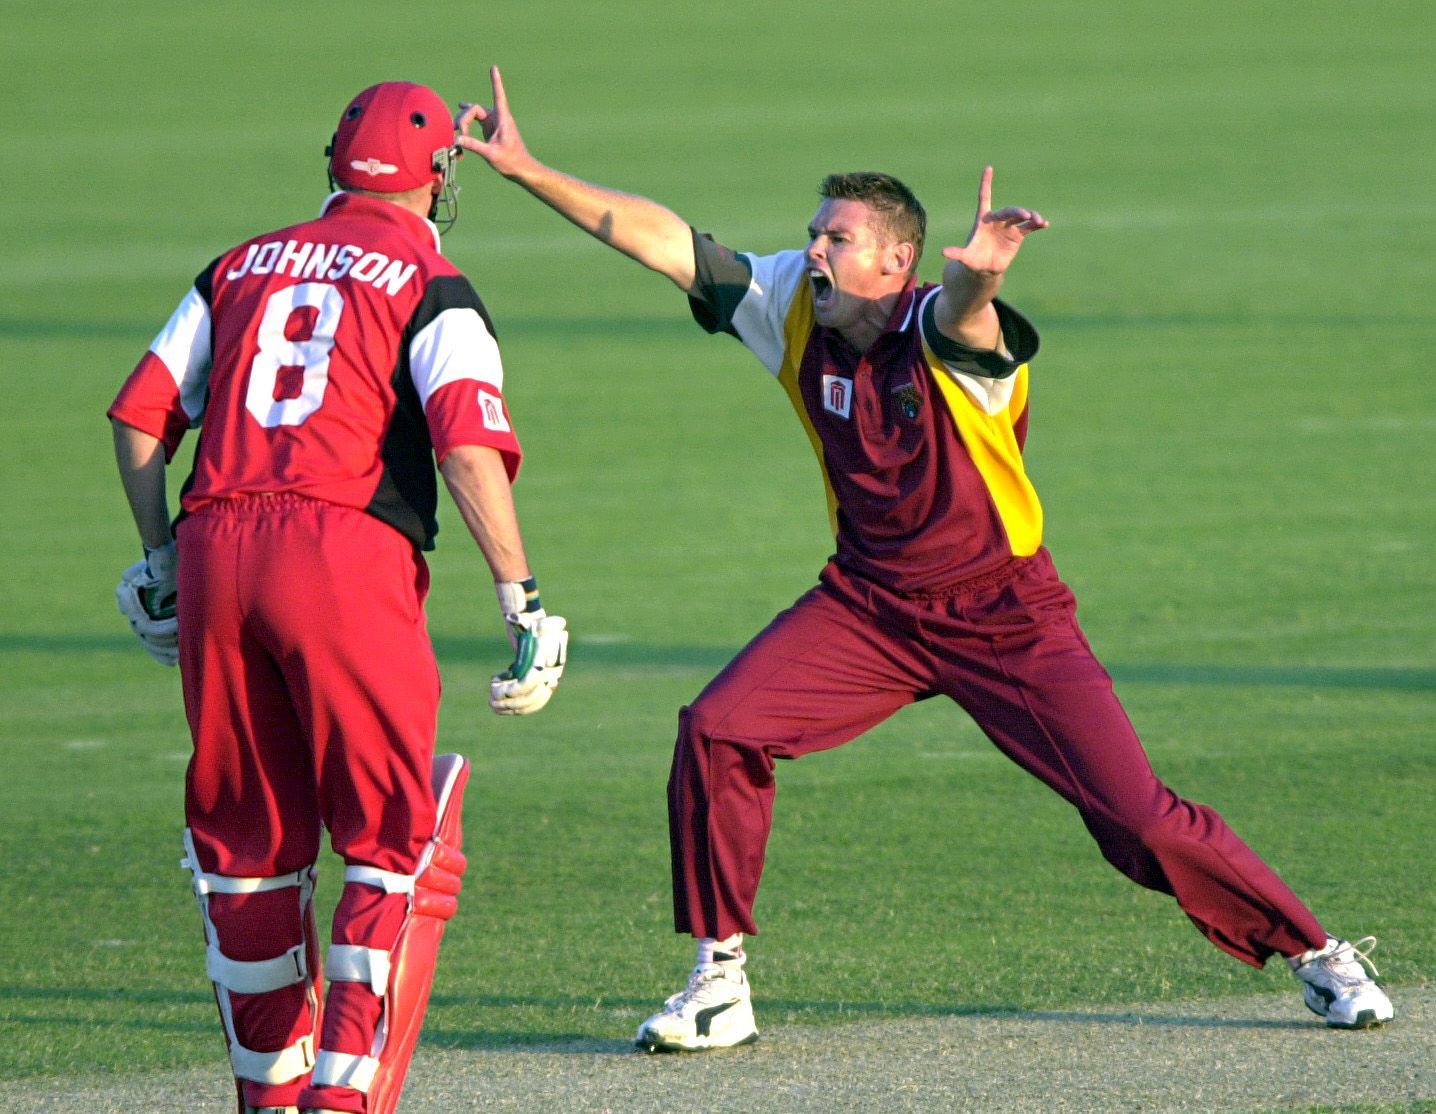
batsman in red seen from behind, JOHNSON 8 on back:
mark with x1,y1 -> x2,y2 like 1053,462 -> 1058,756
109,82 -> 569,1114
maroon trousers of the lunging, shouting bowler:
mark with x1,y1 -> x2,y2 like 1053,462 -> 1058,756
668,550 -> 1325,966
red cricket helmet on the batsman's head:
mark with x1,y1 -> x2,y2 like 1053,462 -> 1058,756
327,82 -> 454,194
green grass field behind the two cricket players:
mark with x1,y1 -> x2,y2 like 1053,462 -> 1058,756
0,0 -> 1436,1098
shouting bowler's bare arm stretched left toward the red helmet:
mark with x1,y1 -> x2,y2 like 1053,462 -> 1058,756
454,66 -> 696,293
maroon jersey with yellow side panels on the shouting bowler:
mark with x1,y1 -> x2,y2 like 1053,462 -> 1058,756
692,233 -> 1043,594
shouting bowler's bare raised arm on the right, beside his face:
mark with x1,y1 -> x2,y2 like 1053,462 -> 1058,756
933,167 -> 1047,350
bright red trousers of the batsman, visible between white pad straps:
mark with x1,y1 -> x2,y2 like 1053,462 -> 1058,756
178,494 -> 439,1107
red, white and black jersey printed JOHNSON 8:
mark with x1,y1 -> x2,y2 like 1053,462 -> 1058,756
109,192 -> 521,548
